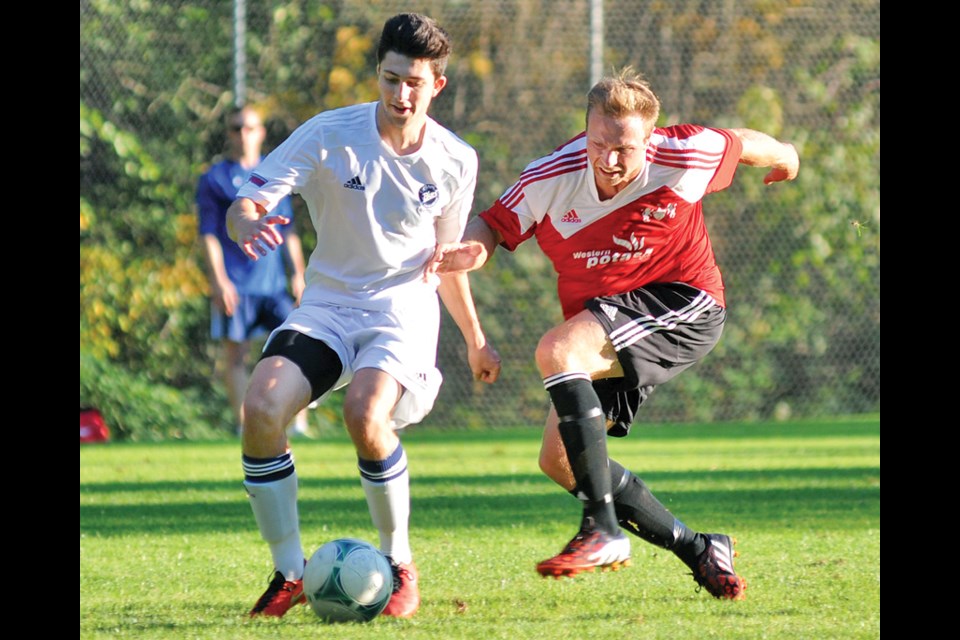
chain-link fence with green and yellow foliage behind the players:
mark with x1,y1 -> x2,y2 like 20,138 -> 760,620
80,0 -> 880,426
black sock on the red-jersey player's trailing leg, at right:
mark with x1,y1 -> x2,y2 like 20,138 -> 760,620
571,460 -> 706,568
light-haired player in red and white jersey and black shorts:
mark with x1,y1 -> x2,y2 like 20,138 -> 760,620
428,68 -> 799,600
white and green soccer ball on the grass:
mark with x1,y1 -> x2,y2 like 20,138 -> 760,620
303,538 -> 393,622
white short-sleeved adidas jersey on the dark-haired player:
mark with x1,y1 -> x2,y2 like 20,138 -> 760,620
237,102 -> 478,311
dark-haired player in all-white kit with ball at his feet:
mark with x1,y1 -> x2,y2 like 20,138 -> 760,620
228,14 -> 500,617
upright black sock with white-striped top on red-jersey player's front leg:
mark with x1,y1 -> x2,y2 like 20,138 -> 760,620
543,373 -> 620,535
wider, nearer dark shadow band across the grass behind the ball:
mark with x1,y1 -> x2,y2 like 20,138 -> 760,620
80,467 -> 880,537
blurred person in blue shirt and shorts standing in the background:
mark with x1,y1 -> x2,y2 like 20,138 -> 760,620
197,107 -> 307,434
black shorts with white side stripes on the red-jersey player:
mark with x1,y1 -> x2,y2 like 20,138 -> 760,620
586,282 -> 727,437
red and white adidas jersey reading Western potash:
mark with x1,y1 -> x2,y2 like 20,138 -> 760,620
480,124 -> 742,318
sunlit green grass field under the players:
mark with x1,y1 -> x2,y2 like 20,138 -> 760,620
80,416 -> 880,640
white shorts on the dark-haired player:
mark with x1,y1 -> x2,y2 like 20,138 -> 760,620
271,297 -> 443,429
